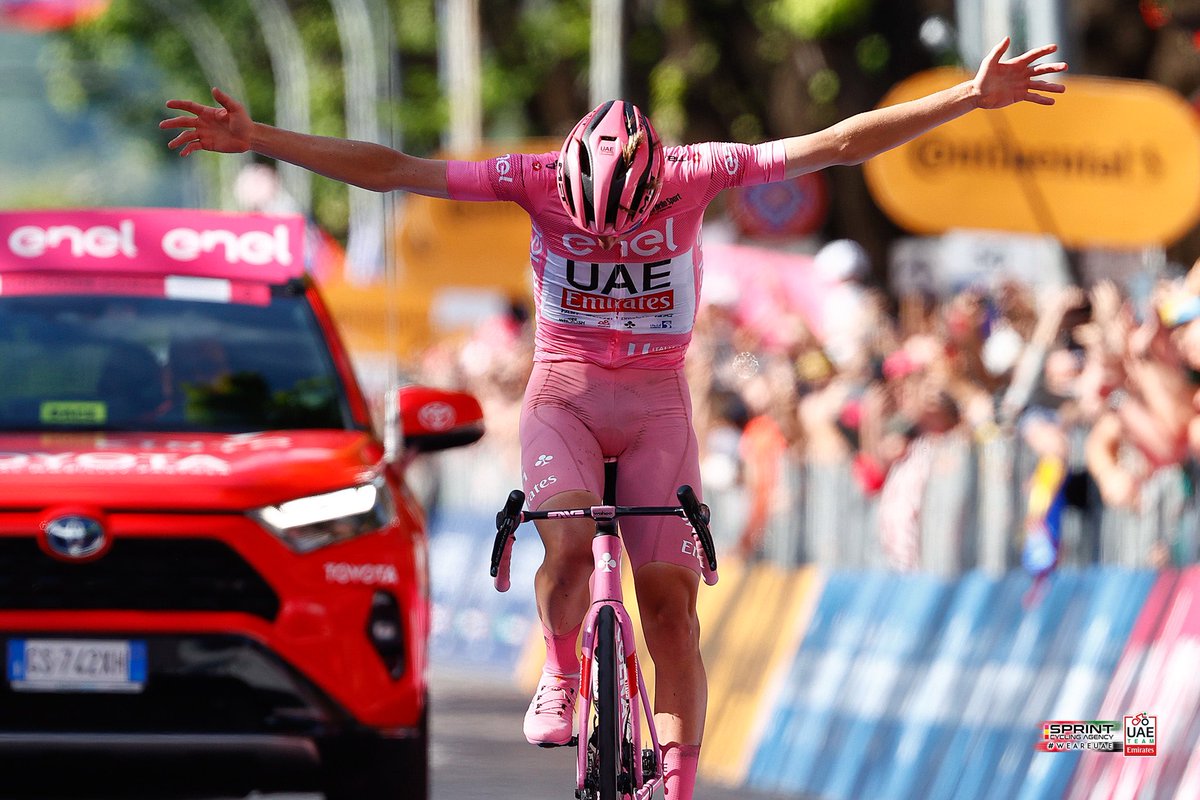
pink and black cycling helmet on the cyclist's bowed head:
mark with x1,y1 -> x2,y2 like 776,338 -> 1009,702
558,100 -> 662,236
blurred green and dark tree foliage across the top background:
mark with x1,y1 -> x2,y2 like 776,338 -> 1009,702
42,0 -> 1200,257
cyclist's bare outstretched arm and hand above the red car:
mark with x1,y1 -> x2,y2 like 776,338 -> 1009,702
158,89 -> 448,197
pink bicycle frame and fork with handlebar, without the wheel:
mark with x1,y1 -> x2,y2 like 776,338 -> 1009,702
491,470 -> 718,800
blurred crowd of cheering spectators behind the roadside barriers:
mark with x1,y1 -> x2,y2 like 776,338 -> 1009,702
422,240 -> 1200,575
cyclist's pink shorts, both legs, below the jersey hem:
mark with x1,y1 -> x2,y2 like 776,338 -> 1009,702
521,361 -> 700,573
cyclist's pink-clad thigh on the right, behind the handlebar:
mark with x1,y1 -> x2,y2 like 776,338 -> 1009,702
617,371 -> 700,572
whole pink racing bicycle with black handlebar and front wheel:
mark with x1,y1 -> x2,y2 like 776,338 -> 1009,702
491,459 -> 718,800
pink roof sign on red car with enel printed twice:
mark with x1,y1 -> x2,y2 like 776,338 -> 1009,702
0,209 -> 305,283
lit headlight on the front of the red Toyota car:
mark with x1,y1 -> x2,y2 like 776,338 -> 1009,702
250,479 -> 396,553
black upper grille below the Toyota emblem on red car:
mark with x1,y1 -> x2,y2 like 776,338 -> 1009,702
0,536 -> 280,620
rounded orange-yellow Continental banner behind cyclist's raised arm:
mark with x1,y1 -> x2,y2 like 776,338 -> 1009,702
864,68 -> 1200,247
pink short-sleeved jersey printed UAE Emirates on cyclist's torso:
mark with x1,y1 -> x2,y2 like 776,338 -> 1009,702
446,142 -> 784,369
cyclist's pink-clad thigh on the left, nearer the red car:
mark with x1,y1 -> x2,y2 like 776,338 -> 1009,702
521,362 -> 604,510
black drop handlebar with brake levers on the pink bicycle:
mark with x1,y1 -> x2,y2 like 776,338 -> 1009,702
490,485 -> 716,591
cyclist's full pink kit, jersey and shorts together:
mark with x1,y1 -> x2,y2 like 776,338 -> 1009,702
446,143 -> 784,573
